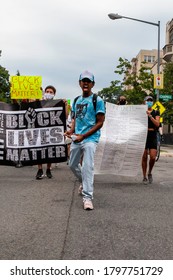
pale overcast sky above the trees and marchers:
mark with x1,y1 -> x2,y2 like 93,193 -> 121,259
0,0 -> 173,99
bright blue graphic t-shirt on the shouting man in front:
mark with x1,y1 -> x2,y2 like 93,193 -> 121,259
72,94 -> 105,142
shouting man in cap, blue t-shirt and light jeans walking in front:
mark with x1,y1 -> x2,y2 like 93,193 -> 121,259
66,71 -> 105,210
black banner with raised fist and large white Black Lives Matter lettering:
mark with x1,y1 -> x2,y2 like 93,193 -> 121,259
0,99 -> 67,166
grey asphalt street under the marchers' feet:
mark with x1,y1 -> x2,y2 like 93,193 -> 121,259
0,147 -> 173,260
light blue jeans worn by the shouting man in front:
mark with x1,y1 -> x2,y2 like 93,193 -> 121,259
69,142 -> 97,199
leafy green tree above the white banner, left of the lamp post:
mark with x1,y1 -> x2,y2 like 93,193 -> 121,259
98,57 -> 153,104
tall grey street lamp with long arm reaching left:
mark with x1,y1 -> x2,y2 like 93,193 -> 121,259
108,13 -> 160,100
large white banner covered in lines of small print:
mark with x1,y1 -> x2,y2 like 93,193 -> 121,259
95,103 -> 148,176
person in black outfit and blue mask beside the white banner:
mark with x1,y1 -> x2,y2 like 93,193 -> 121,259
142,96 -> 160,184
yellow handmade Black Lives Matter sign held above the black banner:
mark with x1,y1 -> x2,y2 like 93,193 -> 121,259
10,76 -> 42,99
